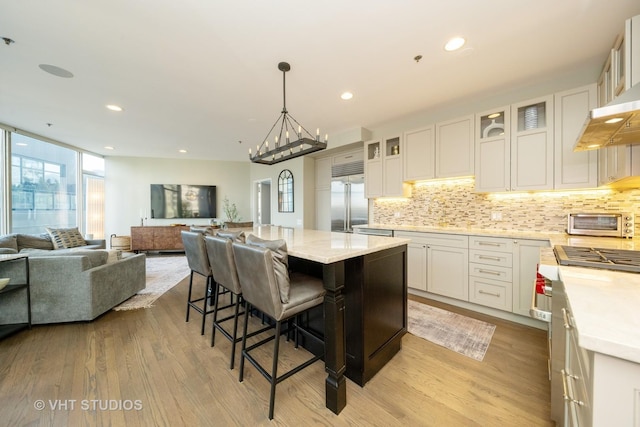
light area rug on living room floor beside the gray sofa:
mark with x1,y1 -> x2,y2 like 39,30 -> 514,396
114,255 -> 191,311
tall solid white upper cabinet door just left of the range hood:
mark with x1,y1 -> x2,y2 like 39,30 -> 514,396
553,84 -> 598,190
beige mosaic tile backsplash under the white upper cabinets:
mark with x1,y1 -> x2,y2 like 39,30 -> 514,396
372,179 -> 640,236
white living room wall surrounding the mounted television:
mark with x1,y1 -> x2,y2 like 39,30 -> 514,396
105,157 -> 252,237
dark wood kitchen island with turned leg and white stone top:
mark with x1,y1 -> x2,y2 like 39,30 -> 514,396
245,226 -> 409,414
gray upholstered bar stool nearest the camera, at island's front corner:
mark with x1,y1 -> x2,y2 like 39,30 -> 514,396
233,238 -> 325,419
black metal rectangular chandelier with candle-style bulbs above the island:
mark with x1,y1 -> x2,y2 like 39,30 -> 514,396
249,62 -> 328,165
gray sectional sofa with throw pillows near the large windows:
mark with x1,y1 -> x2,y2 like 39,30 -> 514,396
0,234 -> 146,324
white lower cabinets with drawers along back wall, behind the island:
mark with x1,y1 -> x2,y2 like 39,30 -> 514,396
394,230 -> 549,318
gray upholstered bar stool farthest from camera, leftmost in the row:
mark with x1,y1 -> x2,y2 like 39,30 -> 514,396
181,231 -> 213,335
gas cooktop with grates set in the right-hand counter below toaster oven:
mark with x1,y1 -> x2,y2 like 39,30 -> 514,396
553,246 -> 640,273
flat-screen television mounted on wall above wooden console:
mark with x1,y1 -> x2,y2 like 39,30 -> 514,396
151,184 -> 216,218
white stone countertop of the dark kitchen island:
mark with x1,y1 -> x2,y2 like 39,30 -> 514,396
245,226 -> 410,264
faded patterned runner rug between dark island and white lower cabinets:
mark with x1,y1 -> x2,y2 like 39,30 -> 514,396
408,300 -> 496,362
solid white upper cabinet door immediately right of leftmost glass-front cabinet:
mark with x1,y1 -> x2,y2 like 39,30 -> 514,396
402,125 -> 436,181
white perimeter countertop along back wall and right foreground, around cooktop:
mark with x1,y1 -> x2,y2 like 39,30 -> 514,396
363,224 -> 640,363
